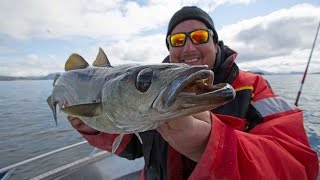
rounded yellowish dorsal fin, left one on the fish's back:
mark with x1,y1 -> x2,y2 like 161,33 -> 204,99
64,53 -> 89,71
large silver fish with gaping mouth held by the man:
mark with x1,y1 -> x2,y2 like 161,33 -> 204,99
48,48 -> 235,152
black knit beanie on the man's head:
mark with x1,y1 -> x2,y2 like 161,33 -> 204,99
166,6 -> 218,49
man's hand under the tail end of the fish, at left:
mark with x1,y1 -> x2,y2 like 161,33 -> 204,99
67,116 -> 100,135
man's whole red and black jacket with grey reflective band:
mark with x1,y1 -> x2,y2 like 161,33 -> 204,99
79,44 -> 319,180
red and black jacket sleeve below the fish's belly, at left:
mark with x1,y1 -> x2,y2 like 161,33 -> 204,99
80,132 -> 142,160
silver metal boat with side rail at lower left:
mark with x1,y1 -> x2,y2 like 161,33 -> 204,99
0,141 -> 144,180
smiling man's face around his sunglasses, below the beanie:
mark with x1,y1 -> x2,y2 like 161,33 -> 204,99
169,20 -> 217,69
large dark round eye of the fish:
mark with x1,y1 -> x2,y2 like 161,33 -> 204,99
136,68 -> 153,92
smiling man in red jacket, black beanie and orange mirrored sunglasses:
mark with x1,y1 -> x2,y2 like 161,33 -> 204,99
68,6 -> 319,179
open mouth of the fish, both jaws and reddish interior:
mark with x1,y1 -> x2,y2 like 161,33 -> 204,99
153,66 -> 235,112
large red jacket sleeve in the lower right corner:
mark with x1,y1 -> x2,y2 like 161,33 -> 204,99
190,111 -> 319,180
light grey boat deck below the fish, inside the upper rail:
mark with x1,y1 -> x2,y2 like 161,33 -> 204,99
33,152 -> 144,180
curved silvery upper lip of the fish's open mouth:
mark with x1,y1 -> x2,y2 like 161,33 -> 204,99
152,65 -> 214,111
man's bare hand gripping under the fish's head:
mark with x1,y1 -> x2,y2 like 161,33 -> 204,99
157,111 -> 211,162
